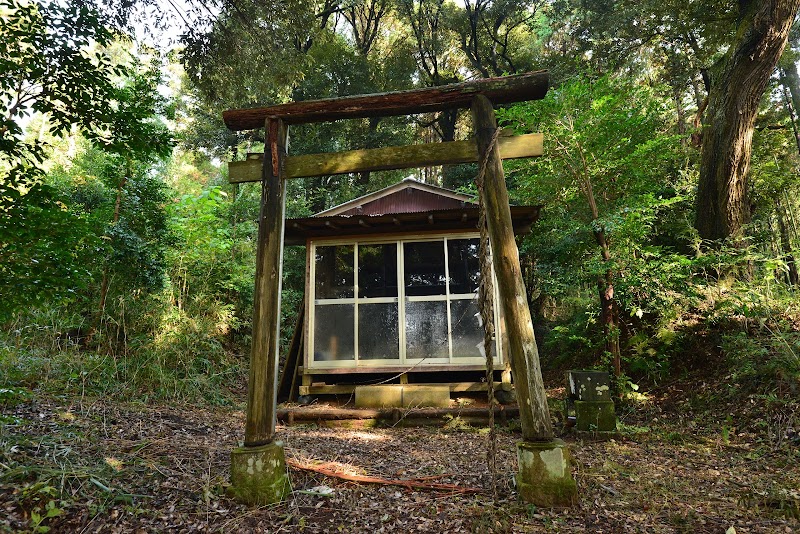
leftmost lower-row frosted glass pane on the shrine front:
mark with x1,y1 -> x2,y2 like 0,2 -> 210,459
314,304 -> 355,362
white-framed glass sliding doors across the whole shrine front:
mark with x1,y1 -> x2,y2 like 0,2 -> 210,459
309,236 -> 499,368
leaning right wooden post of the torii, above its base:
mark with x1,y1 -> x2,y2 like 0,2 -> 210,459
472,95 -> 553,441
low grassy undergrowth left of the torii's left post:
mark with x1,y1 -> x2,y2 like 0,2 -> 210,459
0,292 -> 245,404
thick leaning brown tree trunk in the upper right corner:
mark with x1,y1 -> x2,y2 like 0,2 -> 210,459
695,0 -> 800,240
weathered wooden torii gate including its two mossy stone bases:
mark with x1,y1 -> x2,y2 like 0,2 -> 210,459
223,71 -> 577,506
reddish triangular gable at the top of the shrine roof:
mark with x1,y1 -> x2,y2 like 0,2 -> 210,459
314,178 -> 475,217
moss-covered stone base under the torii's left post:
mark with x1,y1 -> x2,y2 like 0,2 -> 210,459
230,442 -> 292,505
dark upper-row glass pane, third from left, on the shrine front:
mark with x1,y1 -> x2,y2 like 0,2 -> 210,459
403,241 -> 446,297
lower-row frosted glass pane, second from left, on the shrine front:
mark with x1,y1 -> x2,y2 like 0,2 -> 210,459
358,302 -> 400,360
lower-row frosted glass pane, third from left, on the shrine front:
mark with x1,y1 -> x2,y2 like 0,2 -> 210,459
406,301 -> 449,359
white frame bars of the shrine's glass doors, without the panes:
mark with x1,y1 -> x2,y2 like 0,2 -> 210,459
306,232 -> 503,370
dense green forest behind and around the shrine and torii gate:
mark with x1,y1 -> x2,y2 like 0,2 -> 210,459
0,0 -> 800,410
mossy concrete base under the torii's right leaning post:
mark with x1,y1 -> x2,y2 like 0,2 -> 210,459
517,439 -> 578,508
